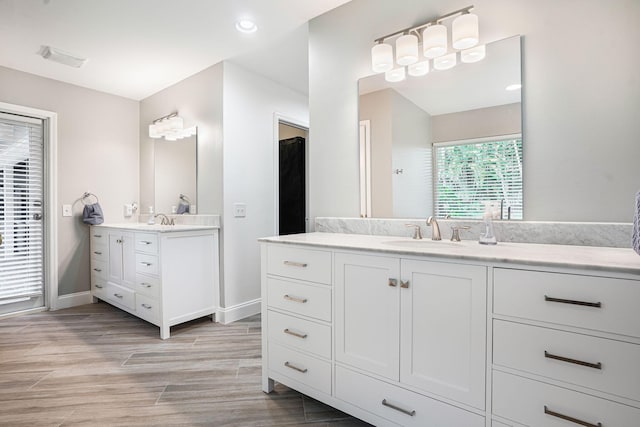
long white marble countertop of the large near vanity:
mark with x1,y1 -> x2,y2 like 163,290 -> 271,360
259,232 -> 640,274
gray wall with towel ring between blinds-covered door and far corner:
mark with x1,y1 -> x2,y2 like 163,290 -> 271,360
0,67 -> 139,295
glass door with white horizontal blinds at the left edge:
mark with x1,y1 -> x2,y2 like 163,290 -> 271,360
0,113 -> 44,304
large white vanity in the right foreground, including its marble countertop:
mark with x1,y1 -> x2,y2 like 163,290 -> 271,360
261,233 -> 640,427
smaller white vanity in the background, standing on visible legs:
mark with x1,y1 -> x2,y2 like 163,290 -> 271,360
90,223 -> 219,339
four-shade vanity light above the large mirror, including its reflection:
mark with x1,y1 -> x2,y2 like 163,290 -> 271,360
371,5 -> 485,82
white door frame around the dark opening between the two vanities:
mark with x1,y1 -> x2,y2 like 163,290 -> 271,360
273,112 -> 309,236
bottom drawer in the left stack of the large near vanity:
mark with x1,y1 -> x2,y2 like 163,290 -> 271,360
269,342 -> 331,394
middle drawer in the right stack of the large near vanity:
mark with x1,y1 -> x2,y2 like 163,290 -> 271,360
493,320 -> 640,401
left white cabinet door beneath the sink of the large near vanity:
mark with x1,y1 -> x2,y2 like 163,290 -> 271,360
335,253 -> 400,380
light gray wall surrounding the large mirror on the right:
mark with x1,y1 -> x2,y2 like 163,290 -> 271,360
309,0 -> 640,222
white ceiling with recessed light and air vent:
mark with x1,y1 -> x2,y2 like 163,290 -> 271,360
0,0 -> 349,100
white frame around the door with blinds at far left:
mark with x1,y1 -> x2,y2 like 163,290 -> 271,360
0,102 -> 58,310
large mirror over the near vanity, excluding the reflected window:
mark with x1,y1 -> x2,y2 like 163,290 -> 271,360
359,37 -> 522,218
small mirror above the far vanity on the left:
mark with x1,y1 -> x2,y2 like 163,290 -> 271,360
153,136 -> 197,214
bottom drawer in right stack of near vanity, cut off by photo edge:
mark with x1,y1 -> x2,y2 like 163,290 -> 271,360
493,371 -> 640,427
